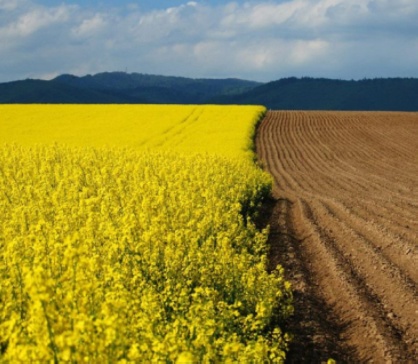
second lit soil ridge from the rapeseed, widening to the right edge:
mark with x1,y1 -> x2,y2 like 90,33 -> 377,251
311,202 -> 418,353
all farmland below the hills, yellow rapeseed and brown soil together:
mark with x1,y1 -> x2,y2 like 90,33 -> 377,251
4,105 -> 418,363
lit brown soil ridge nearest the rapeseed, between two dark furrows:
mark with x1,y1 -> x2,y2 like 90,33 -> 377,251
300,200 -> 401,362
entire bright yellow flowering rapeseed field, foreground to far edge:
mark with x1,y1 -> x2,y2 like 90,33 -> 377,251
0,105 -> 292,363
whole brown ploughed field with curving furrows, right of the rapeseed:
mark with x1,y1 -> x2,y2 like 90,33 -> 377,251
256,111 -> 418,363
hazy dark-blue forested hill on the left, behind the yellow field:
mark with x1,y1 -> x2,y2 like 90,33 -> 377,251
0,72 -> 261,104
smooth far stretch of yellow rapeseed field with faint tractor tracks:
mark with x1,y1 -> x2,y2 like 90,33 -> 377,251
0,105 -> 265,158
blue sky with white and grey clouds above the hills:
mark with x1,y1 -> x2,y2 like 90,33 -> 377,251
0,0 -> 418,82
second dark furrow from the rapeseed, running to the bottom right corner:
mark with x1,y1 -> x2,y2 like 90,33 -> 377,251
301,200 -> 415,362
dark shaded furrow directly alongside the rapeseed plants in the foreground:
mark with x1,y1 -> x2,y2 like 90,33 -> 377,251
267,197 -> 354,364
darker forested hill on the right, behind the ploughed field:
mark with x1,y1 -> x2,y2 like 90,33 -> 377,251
213,77 -> 418,111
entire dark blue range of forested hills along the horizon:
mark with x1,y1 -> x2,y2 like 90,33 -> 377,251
0,72 -> 418,111
